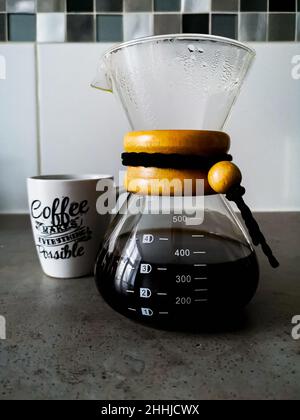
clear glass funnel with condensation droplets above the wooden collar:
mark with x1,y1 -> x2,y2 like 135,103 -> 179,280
92,34 -> 255,130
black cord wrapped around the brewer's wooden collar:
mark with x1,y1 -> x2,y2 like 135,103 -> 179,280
122,153 -> 232,170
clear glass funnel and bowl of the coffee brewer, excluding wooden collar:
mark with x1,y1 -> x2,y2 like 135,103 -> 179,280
93,35 -> 259,328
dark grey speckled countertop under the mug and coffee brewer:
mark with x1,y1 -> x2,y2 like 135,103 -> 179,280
0,213 -> 300,399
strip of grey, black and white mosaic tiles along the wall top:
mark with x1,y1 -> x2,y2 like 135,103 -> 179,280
0,0 -> 300,42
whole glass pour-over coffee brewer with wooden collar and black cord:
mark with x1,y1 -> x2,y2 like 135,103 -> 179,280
93,35 -> 277,328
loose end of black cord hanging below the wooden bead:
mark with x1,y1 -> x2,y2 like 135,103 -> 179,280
226,185 -> 280,268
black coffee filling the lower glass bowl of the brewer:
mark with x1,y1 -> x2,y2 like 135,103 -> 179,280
96,205 -> 259,328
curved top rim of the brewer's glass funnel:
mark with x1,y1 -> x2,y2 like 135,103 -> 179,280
104,34 -> 256,57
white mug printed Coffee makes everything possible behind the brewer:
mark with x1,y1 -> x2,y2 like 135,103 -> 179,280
27,175 -> 113,278
